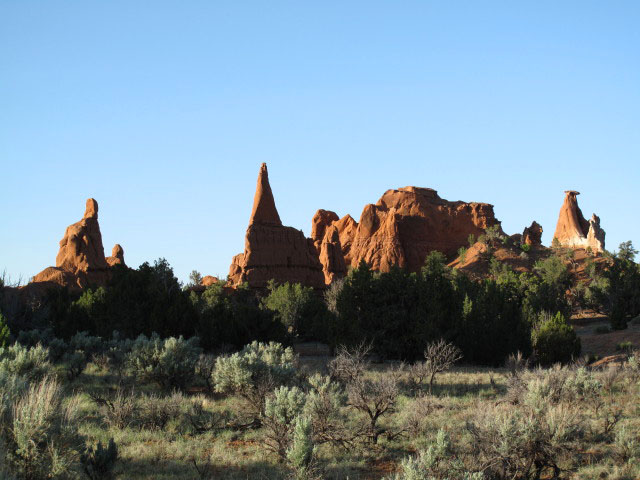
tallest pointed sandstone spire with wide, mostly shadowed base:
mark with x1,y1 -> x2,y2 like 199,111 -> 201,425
229,163 -> 325,288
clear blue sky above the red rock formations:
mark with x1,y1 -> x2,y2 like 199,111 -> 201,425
0,0 -> 640,281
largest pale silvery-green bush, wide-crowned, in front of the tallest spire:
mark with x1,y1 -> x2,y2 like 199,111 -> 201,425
212,342 -> 297,418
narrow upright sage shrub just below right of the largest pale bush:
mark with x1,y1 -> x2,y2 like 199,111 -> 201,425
263,386 -> 305,460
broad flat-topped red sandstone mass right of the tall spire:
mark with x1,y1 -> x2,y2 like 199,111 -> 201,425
313,187 -> 500,277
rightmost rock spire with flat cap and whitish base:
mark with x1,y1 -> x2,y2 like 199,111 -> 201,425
553,190 -> 605,252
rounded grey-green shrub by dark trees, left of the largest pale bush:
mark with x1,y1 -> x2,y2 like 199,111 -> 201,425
127,334 -> 202,389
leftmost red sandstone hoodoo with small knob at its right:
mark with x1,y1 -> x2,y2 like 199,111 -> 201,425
32,198 -> 124,288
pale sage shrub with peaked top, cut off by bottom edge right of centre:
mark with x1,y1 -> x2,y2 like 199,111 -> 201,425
392,429 -> 485,480
